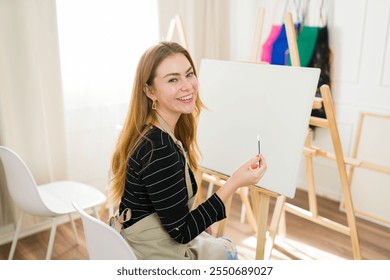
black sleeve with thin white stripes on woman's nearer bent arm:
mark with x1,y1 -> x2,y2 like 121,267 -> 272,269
141,131 -> 226,244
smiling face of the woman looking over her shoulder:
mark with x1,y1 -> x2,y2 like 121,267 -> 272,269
148,53 -> 198,123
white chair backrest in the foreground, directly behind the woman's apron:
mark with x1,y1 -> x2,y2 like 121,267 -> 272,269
72,202 -> 137,260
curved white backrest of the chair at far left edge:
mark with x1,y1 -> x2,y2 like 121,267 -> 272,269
0,146 -> 53,216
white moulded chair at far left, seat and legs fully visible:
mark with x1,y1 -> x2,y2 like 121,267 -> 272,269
0,146 -> 107,260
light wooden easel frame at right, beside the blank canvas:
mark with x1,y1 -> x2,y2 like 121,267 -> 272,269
266,14 -> 362,259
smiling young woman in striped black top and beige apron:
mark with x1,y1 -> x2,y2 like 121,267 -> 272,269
110,42 -> 266,259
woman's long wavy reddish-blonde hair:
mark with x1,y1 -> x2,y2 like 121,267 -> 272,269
108,42 -> 204,203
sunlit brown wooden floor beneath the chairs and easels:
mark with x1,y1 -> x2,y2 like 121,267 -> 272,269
0,190 -> 390,260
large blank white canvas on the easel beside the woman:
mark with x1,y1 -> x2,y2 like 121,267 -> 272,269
198,59 -> 320,198
